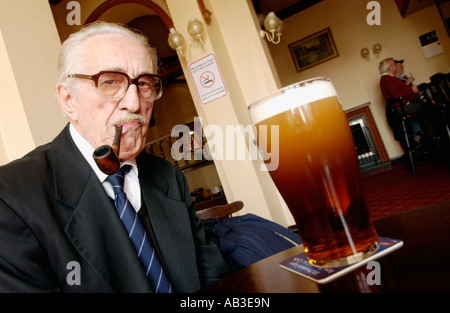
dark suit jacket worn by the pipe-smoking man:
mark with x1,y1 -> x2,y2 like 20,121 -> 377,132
0,123 -> 228,292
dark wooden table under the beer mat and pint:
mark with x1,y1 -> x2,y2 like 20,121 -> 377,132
200,201 -> 450,293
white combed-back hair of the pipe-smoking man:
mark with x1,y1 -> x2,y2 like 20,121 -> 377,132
57,21 -> 158,87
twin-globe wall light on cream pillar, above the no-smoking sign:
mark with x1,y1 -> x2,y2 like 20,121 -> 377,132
168,18 -> 204,58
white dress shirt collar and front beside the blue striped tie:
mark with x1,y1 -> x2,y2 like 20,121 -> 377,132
69,124 -> 141,212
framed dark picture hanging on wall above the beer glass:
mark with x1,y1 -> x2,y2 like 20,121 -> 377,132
289,28 -> 339,72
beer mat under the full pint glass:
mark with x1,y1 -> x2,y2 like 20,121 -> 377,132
279,237 -> 403,284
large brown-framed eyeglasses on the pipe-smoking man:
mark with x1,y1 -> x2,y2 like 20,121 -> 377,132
68,71 -> 162,100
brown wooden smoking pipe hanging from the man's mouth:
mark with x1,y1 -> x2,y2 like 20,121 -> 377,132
92,126 -> 122,175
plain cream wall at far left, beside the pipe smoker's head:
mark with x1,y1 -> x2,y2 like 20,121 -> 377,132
0,0 -> 66,164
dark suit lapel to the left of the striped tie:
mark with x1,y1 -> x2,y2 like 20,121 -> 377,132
54,128 -> 151,292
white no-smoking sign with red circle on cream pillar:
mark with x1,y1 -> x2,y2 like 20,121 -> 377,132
189,53 -> 228,105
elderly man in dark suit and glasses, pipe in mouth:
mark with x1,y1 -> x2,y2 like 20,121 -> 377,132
0,23 -> 228,292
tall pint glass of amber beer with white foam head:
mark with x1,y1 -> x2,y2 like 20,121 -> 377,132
249,78 -> 379,267
